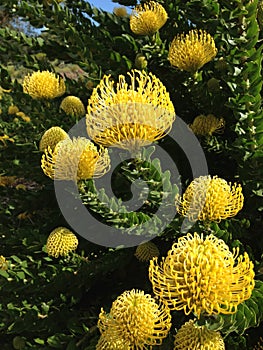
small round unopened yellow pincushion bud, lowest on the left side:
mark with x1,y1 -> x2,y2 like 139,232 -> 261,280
47,227 -> 78,258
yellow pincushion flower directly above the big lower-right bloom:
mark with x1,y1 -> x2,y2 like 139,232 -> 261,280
176,175 -> 244,222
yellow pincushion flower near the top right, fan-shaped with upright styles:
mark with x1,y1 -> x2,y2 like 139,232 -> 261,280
168,29 -> 217,73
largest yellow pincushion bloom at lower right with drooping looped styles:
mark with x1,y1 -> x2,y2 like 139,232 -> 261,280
149,233 -> 255,318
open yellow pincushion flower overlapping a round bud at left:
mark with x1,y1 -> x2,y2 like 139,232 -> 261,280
41,137 -> 110,181
